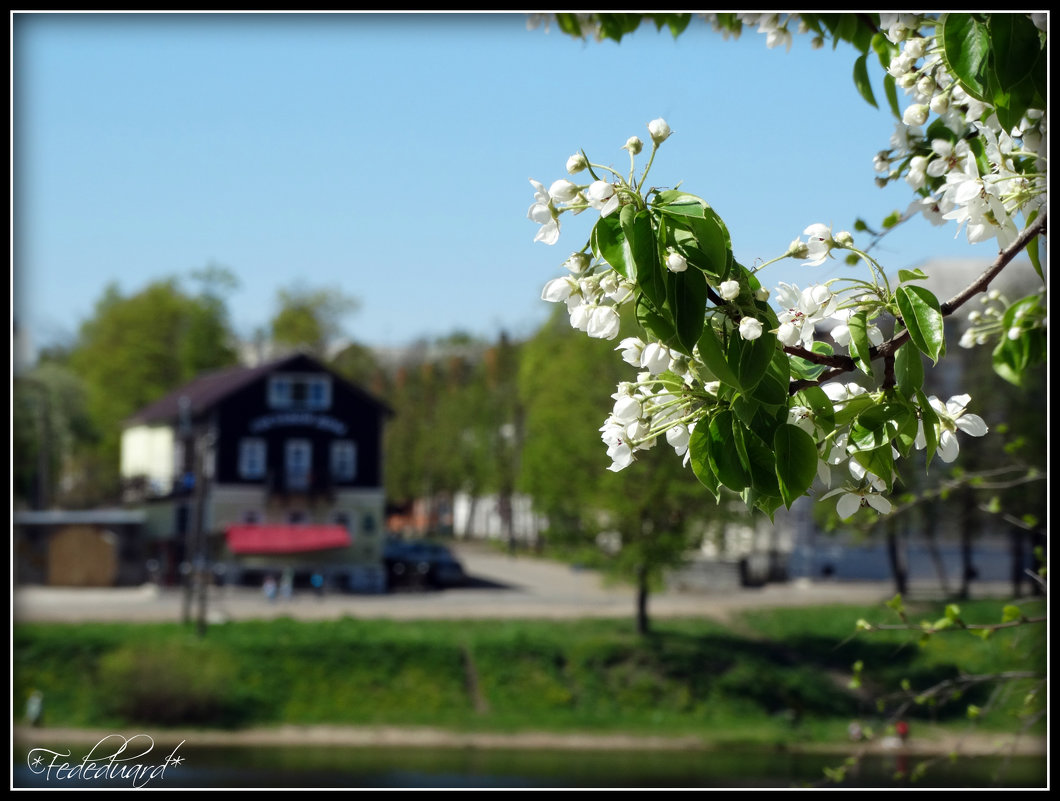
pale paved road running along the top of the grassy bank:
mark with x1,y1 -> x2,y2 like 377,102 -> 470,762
13,544 -> 1007,622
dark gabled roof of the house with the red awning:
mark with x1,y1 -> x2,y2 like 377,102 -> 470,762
124,353 -> 393,427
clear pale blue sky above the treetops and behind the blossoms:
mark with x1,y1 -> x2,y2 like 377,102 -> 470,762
12,14 -> 992,356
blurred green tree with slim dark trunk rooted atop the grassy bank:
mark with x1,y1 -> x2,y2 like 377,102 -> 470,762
519,307 -> 728,634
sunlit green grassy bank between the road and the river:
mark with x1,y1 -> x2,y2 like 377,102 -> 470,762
13,601 -> 1045,743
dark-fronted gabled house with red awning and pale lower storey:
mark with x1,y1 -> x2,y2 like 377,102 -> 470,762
121,354 -> 391,591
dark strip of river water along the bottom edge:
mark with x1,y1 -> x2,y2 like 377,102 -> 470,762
12,744 -> 1047,789
